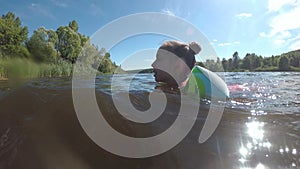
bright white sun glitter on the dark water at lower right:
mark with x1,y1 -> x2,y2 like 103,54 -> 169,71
236,113 -> 300,169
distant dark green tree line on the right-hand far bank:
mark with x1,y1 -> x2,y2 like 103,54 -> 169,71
197,49 -> 300,72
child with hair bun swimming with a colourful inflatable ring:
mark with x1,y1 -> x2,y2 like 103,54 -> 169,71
152,41 -> 229,99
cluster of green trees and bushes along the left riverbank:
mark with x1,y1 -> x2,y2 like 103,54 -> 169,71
0,12 -> 118,79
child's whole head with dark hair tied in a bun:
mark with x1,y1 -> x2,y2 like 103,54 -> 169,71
152,41 -> 201,86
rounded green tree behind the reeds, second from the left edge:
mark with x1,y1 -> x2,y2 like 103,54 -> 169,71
26,28 -> 58,62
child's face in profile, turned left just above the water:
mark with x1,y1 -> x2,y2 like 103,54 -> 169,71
152,49 -> 191,86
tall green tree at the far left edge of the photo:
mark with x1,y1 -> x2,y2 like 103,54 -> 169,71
0,12 -> 29,57
